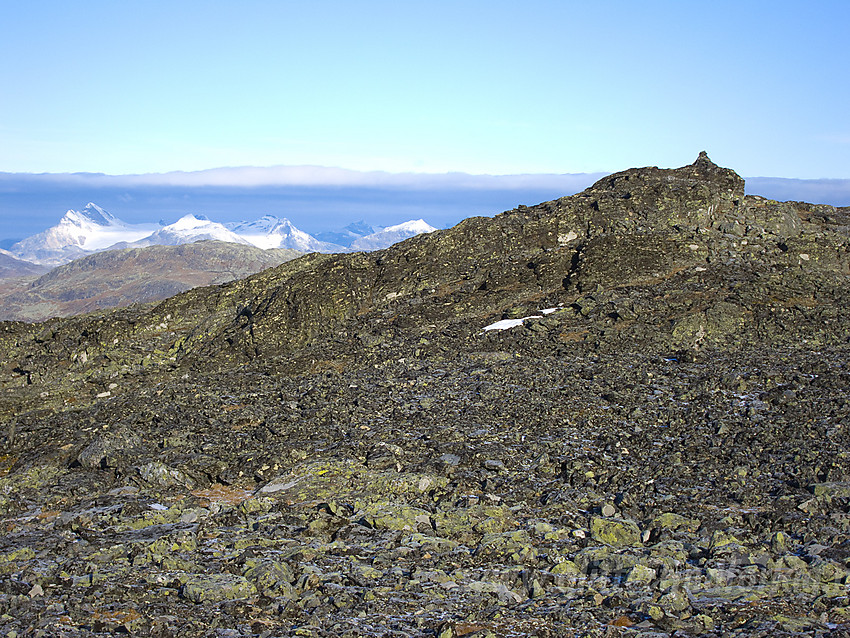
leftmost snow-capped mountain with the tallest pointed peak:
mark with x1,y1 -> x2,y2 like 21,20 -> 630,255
9,203 -> 159,266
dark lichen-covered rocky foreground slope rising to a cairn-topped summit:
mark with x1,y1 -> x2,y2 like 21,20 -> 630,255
0,153 -> 850,638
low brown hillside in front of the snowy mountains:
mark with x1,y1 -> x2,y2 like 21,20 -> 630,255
0,241 -> 301,321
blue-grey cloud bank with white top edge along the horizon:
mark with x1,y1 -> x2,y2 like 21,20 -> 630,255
0,166 -> 850,242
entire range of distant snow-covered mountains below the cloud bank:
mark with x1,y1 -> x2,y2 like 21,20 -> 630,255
9,203 -> 436,266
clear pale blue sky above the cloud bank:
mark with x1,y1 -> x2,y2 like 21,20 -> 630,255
0,0 -> 850,178
